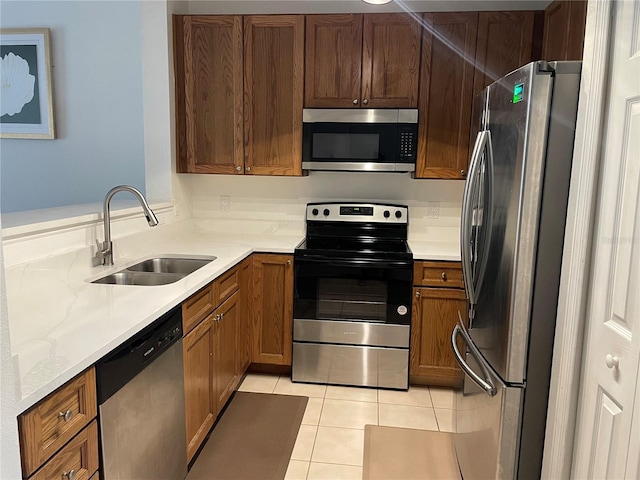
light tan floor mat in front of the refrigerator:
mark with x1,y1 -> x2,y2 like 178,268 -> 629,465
362,425 -> 461,480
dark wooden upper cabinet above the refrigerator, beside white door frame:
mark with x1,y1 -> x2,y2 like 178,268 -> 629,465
542,0 -> 587,61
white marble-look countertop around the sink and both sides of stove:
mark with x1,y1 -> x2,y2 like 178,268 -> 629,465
5,220 -> 460,412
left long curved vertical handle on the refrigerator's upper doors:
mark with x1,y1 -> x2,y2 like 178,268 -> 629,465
460,130 -> 489,305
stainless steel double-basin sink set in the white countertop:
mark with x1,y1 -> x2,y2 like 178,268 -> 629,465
91,255 -> 217,286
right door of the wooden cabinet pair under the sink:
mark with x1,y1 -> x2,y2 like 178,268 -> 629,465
213,292 -> 240,412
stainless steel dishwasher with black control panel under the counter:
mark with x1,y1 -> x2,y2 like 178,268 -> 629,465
96,307 -> 187,480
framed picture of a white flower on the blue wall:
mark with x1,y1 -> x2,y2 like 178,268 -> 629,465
0,28 -> 55,139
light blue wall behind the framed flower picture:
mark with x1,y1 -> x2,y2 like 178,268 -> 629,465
0,0 -> 148,212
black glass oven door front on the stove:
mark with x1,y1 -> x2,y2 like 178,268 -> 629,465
294,260 -> 412,325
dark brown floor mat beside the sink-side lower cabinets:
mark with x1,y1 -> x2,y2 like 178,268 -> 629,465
186,392 -> 309,480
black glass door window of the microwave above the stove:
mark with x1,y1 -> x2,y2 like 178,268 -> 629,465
302,123 -> 398,163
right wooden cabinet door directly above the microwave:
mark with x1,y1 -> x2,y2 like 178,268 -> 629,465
362,14 -> 421,108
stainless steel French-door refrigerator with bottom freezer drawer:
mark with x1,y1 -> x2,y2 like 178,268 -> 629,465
451,62 -> 581,480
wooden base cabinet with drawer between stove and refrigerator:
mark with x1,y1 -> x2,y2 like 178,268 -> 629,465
409,262 -> 468,387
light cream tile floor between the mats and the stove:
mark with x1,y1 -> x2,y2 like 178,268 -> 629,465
239,374 -> 453,480
